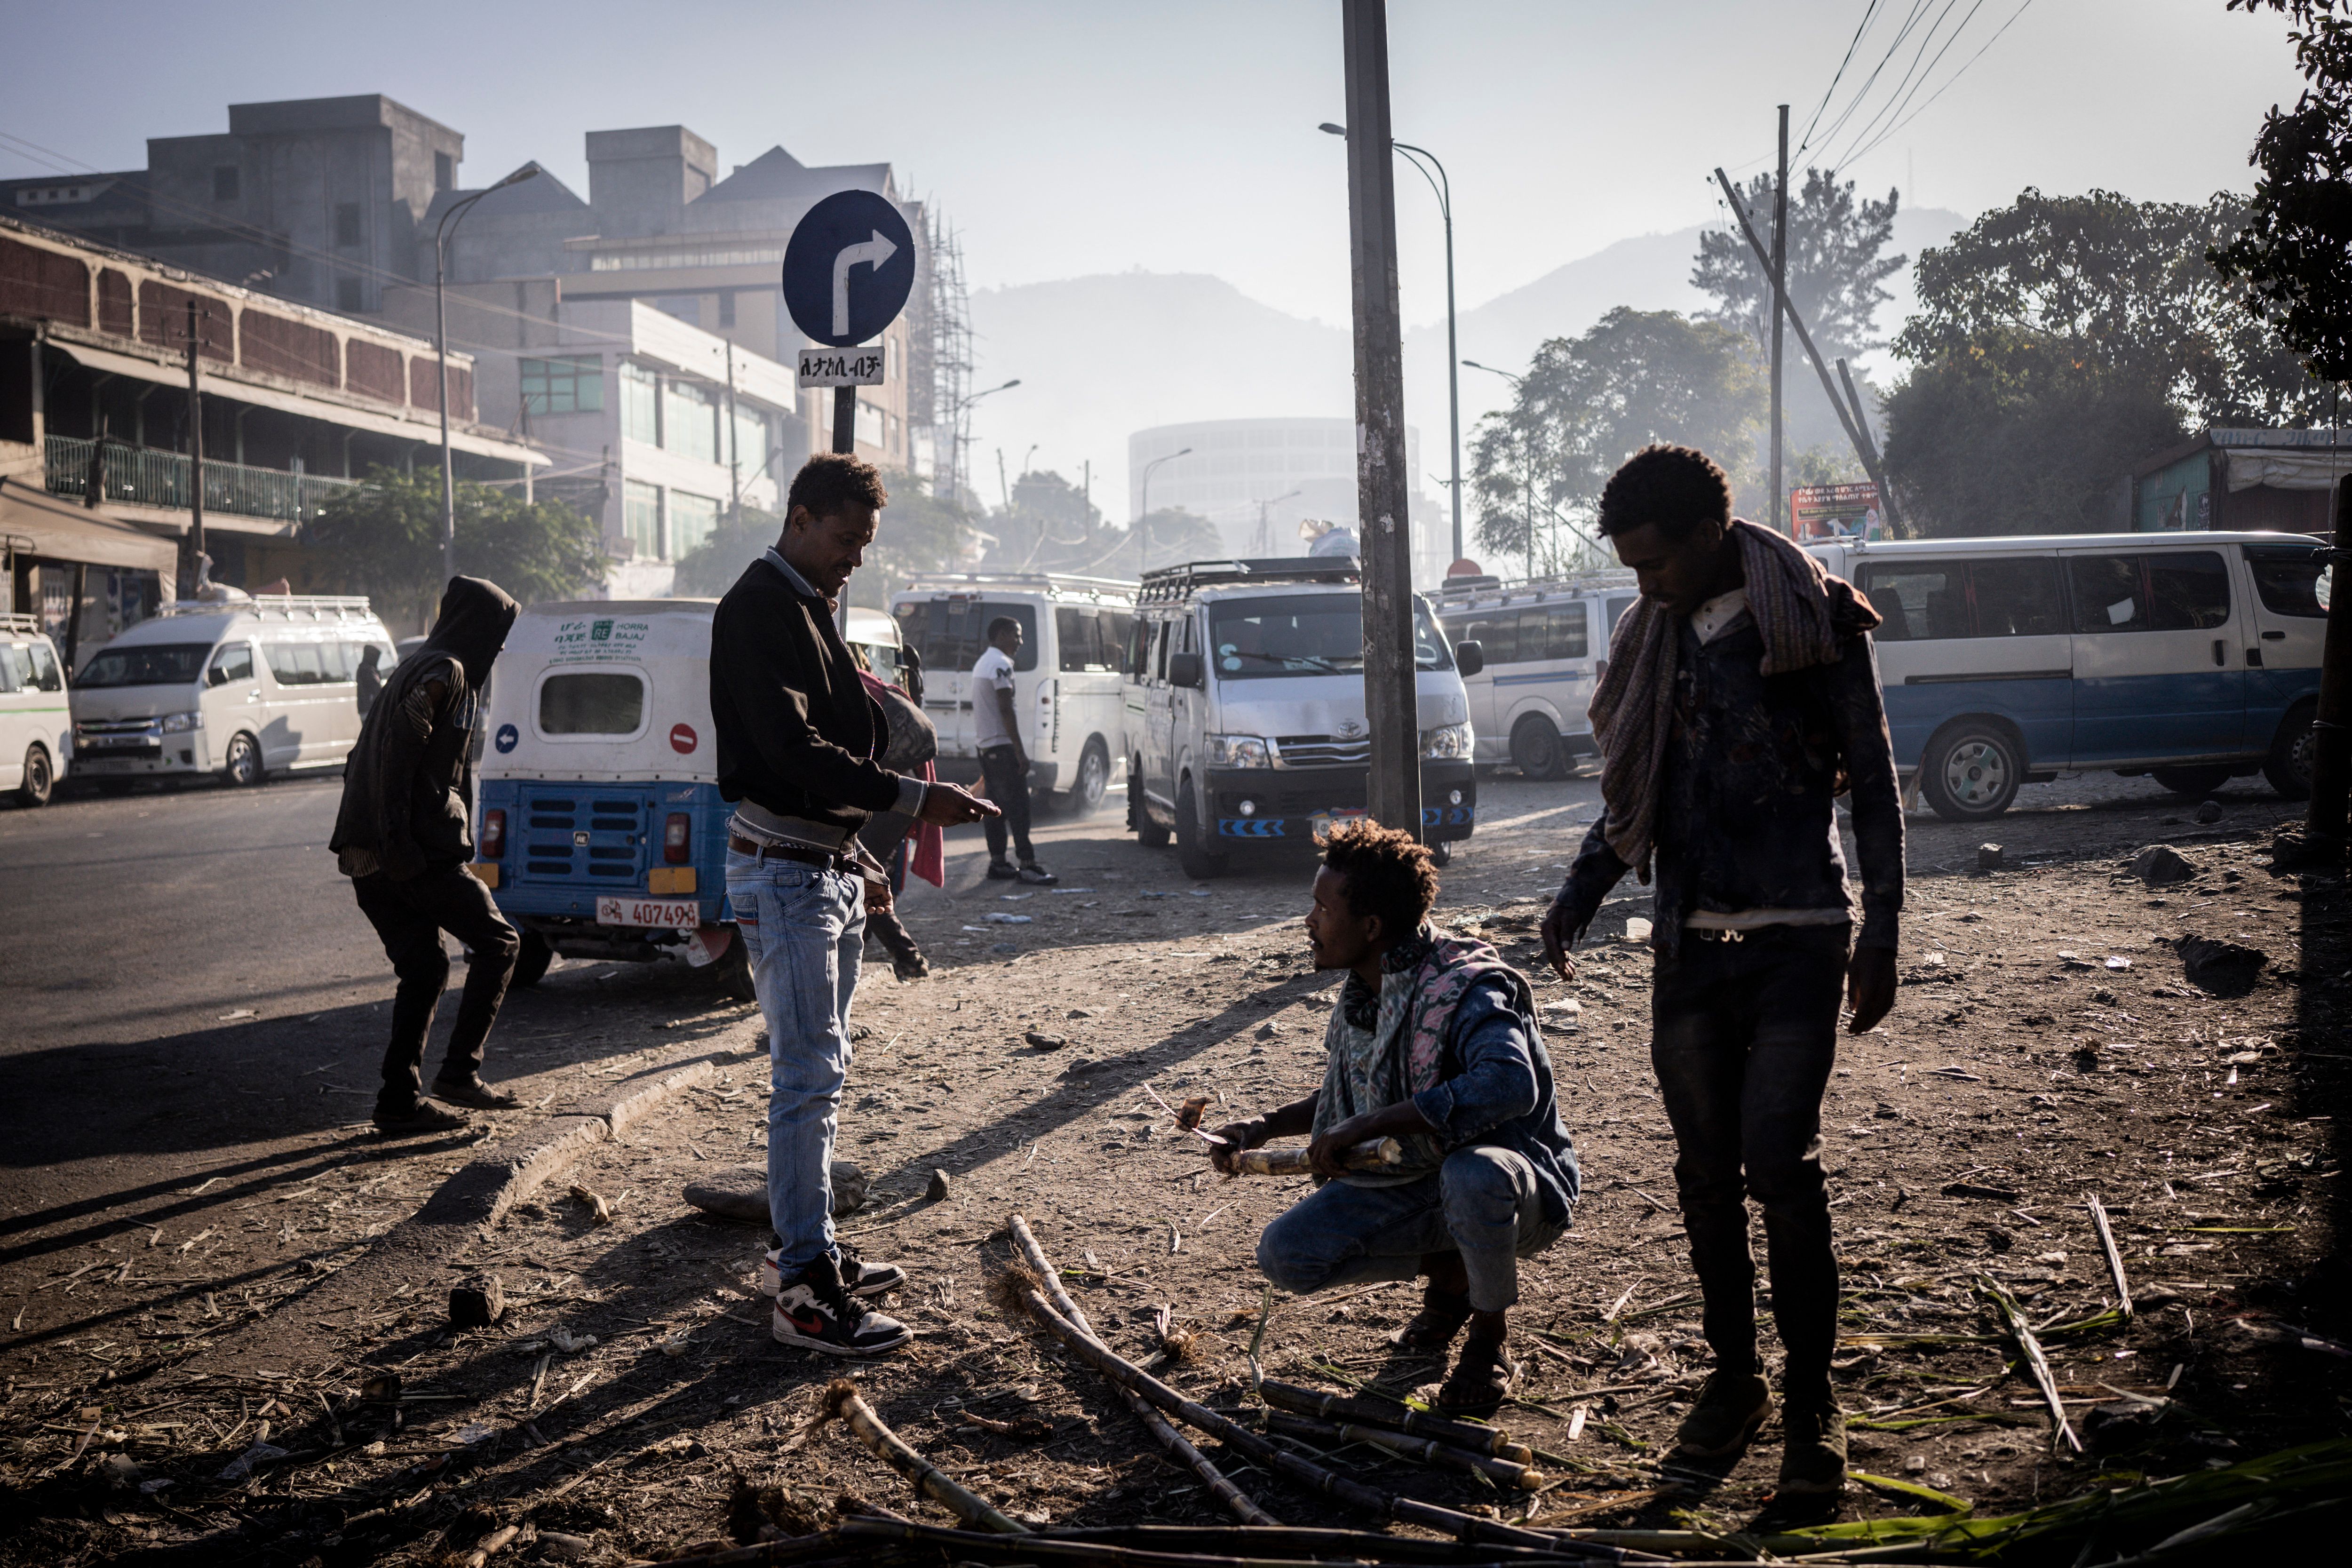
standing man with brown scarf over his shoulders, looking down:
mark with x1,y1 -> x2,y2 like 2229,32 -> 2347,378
1543,446 -> 1903,1495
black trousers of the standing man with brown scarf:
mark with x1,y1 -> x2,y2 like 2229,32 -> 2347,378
1651,926 -> 1851,1399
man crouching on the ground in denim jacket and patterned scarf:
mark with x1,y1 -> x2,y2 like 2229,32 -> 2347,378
1216,823 -> 1576,1415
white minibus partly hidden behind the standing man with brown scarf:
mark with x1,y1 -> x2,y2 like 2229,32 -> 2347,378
1437,571 -> 1639,778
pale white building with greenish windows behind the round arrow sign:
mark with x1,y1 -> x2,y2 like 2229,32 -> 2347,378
383,275 -> 809,599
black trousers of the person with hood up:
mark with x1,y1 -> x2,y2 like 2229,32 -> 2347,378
350,865 -> 522,1117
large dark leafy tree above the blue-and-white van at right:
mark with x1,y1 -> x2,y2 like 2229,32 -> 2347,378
1886,188 -> 2326,533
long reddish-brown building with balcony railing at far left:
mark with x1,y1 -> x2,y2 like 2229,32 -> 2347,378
0,214 -> 548,644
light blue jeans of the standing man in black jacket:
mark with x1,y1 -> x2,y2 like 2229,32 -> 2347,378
727,851 -> 866,1279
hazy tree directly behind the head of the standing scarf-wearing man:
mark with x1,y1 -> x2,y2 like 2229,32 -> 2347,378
1470,306 -> 1764,571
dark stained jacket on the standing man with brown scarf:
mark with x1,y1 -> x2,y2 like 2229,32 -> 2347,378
1555,611 -> 1903,957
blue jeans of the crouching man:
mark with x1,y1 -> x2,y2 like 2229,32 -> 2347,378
1258,1145 -> 1566,1312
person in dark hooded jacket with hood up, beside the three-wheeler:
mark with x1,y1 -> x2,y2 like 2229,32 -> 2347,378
327,576 -> 522,1138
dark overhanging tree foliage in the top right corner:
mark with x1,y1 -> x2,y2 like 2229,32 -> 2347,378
2206,0 -> 2352,381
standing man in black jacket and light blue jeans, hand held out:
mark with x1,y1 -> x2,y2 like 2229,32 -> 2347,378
710,454 -> 995,1356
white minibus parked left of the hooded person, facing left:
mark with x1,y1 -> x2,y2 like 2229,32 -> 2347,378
73,592 -> 393,790
